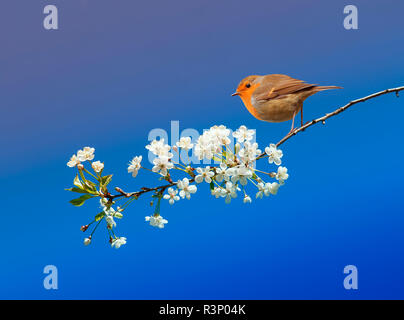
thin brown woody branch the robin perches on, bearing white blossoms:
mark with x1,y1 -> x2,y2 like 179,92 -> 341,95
106,86 -> 404,201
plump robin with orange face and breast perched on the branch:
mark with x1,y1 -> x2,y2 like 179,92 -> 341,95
232,74 -> 342,133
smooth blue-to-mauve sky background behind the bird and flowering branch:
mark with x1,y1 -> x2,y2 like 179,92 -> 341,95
0,0 -> 404,299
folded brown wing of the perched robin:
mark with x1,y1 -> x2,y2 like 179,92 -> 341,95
253,74 -> 316,101
